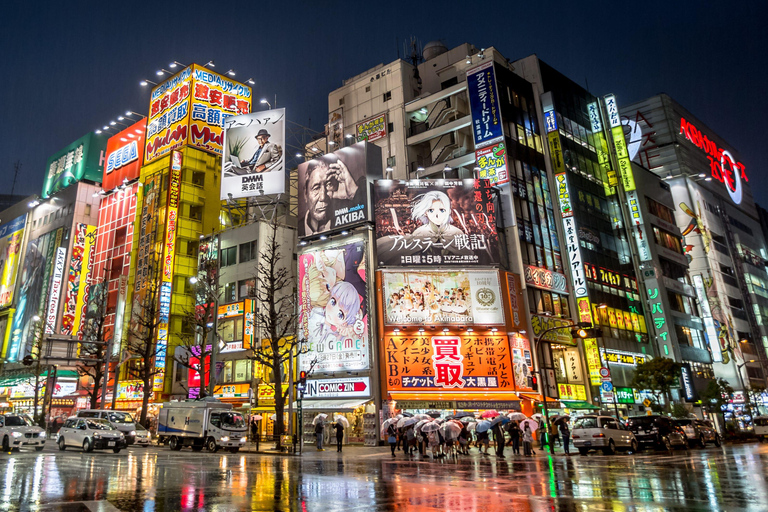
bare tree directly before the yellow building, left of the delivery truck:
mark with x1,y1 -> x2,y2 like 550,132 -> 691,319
125,251 -> 167,427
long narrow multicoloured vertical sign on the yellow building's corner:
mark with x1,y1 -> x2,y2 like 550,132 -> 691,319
152,151 -> 182,391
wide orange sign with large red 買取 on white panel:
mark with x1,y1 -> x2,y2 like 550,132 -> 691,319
382,333 -> 515,399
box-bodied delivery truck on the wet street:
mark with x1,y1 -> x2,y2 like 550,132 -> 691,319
157,397 -> 248,453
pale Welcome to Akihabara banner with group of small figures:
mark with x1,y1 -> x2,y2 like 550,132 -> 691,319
382,270 -> 504,325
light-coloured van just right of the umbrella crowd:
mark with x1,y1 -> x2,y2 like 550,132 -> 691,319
571,415 -> 639,455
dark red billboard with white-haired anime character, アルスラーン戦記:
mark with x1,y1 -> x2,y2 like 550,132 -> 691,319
375,179 -> 499,266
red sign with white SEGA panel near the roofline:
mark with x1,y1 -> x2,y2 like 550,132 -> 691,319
101,119 -> 147,190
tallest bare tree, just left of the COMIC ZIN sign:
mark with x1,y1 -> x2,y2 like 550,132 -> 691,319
252,215 -> 303,450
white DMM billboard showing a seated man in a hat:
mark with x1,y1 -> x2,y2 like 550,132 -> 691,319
221,108 -> 285,199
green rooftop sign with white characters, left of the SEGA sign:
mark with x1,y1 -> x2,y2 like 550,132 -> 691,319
41,133 -> 107,199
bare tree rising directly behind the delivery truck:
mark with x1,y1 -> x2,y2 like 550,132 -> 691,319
173,240 -> 221,398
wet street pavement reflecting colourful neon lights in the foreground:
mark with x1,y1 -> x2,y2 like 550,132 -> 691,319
0,443 -> 768,512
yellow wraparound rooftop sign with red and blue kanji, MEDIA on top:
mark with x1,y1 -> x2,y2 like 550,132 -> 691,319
144,64 -> 251,163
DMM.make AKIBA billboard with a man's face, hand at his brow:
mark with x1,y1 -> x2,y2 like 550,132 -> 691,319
299,142 -> 381,238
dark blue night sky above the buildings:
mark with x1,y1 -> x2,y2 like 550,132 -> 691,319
0,0 -> 768,206
